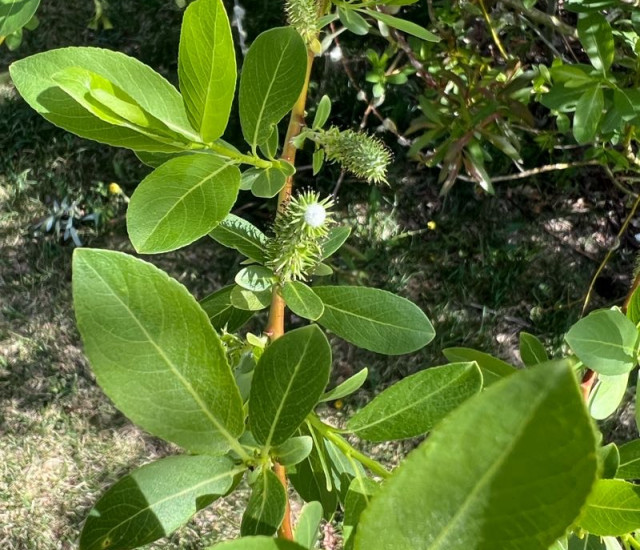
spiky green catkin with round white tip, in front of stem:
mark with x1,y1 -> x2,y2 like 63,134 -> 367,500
267,191 -> 334,283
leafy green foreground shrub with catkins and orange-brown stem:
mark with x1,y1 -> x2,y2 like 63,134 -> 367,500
11,0 -> 640,550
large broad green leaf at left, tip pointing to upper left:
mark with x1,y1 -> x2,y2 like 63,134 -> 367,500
73,248 -> 244,454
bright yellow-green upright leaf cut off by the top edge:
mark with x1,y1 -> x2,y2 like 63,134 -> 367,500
178,0 -> 237,143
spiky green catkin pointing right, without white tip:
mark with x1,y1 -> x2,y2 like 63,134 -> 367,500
310,128 -> 391,183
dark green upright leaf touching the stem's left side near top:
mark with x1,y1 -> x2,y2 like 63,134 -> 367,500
238,27 -> 307,150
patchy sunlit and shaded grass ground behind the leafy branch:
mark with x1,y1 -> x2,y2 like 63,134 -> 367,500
0,0 -> 638,550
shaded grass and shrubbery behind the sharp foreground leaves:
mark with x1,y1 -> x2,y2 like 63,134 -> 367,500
0,0 -> 640,550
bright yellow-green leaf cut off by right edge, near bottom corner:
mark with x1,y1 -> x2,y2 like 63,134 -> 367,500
578,479 -> 640,537
